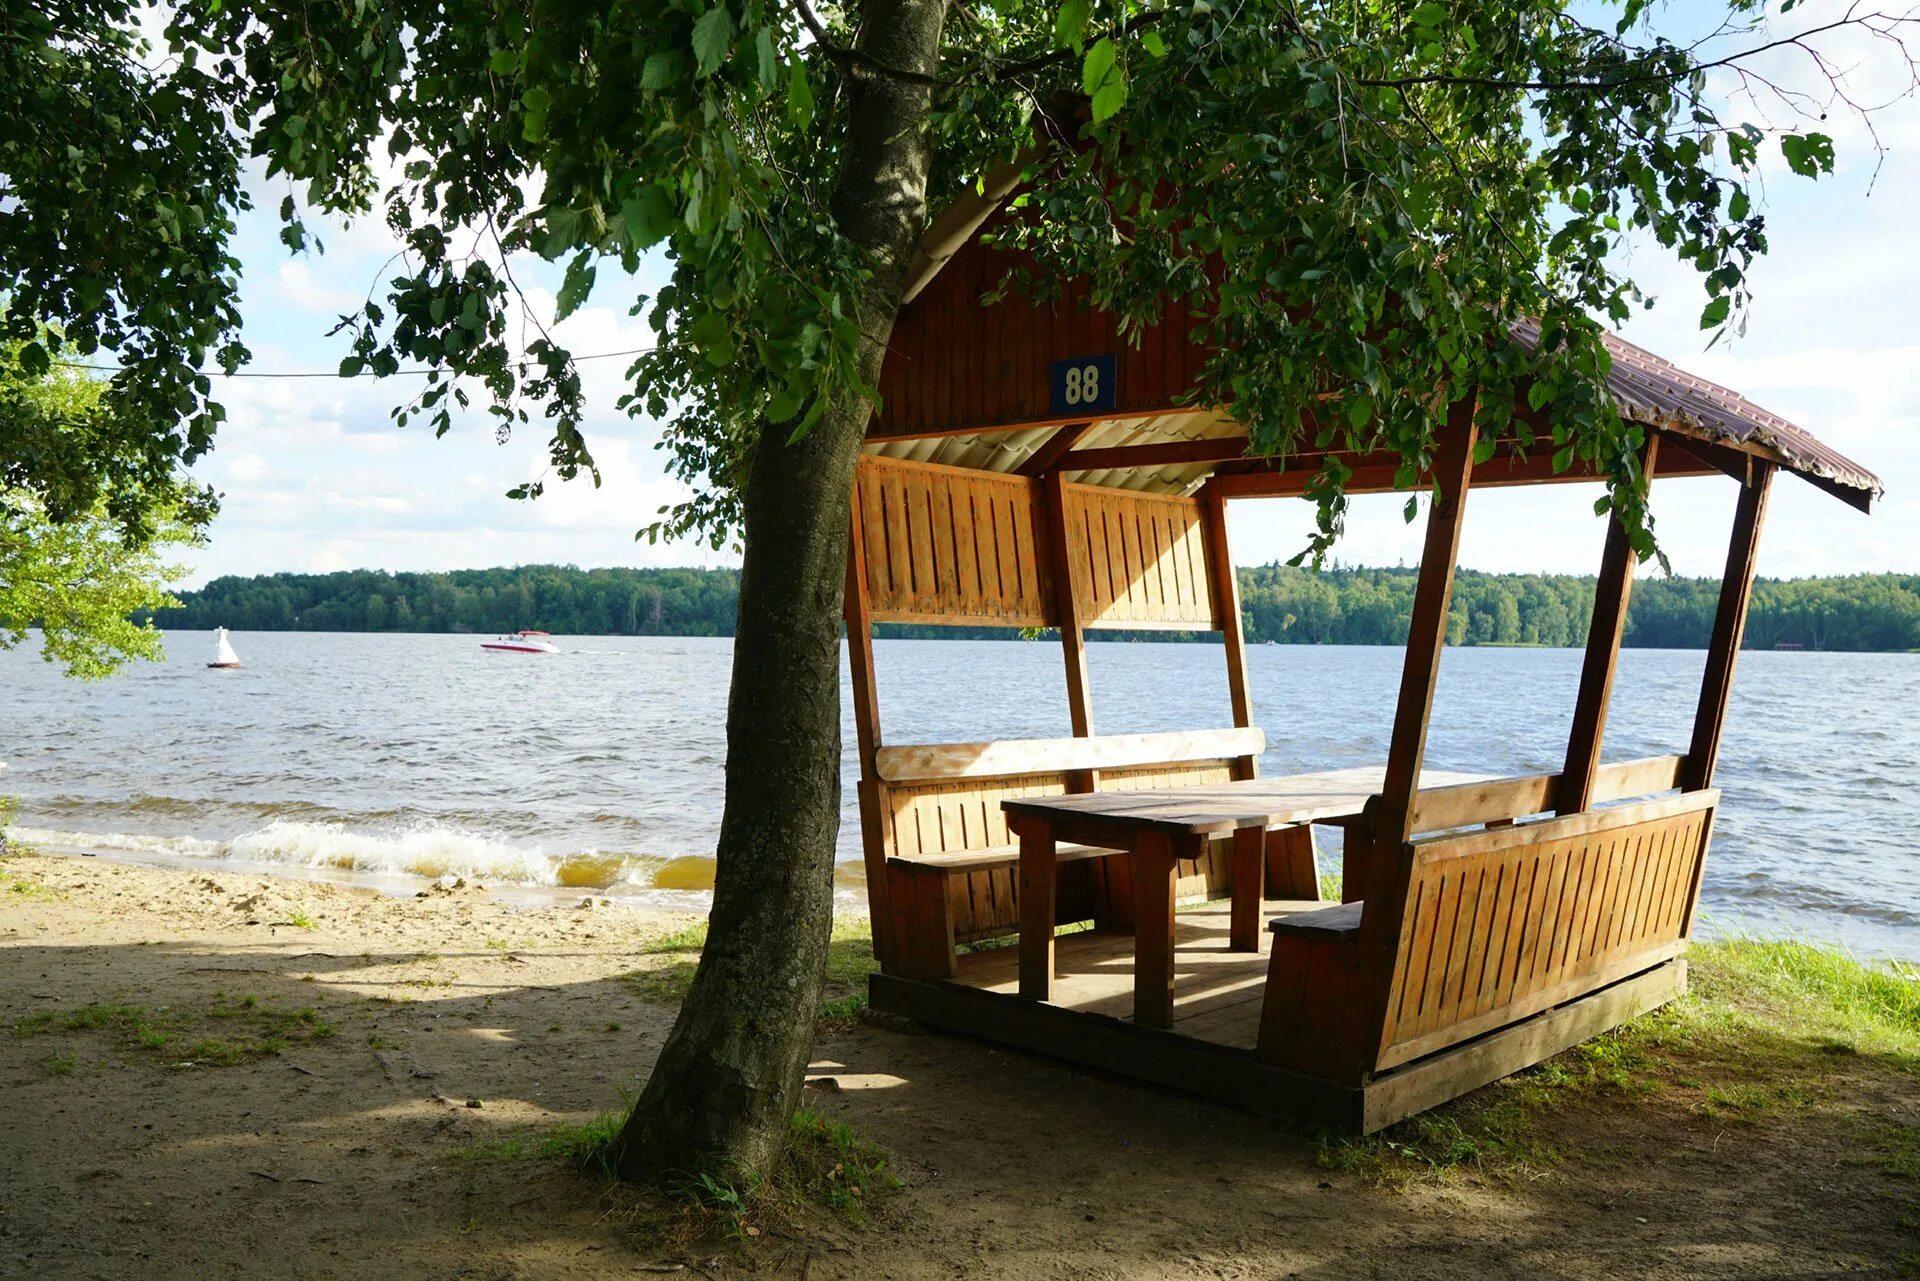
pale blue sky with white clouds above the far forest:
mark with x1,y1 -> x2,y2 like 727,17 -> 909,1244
182,0 -> 1920,586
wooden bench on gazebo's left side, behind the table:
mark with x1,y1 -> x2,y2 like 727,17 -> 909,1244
876,728 -> 1267,979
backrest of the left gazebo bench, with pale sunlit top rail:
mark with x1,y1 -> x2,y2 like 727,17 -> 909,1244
876,728 -> 1265,939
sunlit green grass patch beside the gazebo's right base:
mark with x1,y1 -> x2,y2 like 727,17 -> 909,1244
1319,939 -> 1920,1185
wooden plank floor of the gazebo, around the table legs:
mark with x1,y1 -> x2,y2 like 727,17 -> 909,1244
944,899 -> 1331,1051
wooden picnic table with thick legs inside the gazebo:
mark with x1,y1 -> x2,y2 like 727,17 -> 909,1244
1002,764 -> 1486,1027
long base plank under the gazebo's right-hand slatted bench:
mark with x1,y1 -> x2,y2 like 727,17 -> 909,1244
1361,960 -> 1686,1133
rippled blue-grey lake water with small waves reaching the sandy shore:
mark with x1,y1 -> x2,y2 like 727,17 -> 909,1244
0,632 -> 1920,958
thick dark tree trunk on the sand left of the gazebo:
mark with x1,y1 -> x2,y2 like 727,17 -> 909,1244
614,0 -> 947,1179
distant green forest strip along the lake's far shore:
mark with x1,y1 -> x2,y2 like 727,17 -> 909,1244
154,565 -> 1920,649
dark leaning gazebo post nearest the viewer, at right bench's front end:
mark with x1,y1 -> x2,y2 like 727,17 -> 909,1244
1351,390 -> 1478,1077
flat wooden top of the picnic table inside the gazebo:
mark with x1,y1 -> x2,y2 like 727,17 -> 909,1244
1002,764 -> 1492,834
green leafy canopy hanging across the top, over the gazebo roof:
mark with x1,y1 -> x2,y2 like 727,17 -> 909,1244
0,0 -> 1866,553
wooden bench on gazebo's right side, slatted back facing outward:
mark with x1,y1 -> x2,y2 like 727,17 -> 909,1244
1258,757 -> 1718,1129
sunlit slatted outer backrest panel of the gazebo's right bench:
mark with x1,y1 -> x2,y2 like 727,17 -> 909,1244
1377,791 -> 1720,1070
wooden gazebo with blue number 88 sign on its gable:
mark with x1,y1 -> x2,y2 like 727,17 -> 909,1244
847,184 -> 1882,1131
